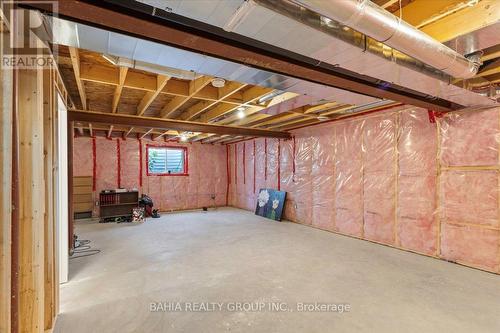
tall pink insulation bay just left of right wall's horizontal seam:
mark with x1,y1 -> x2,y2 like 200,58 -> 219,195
396,108 -> 438,255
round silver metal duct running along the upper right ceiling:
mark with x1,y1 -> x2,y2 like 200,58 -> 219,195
288,0 -> 480,78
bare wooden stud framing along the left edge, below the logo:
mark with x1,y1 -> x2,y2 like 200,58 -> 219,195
0,14 -> 64,332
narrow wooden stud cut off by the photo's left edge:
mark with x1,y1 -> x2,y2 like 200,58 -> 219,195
0,32 -> 13,332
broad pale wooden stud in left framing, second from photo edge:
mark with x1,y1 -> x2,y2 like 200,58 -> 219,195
17,69 -> 45,332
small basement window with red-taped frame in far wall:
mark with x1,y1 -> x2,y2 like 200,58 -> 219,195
146,145 -> 188,176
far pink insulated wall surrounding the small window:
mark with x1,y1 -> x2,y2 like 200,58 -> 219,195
73,136 -> 227,216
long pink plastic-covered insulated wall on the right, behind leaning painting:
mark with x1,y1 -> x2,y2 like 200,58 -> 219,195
227,107 -> 500,273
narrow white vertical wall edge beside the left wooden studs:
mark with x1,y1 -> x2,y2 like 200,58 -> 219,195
56,96 -> 69,283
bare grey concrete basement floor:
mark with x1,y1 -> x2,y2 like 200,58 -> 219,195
55,208 -> 500,333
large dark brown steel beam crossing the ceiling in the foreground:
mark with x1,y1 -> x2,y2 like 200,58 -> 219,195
31,0 -> 460,111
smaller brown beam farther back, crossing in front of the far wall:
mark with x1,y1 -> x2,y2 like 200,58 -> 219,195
68,110 -> 290,138
